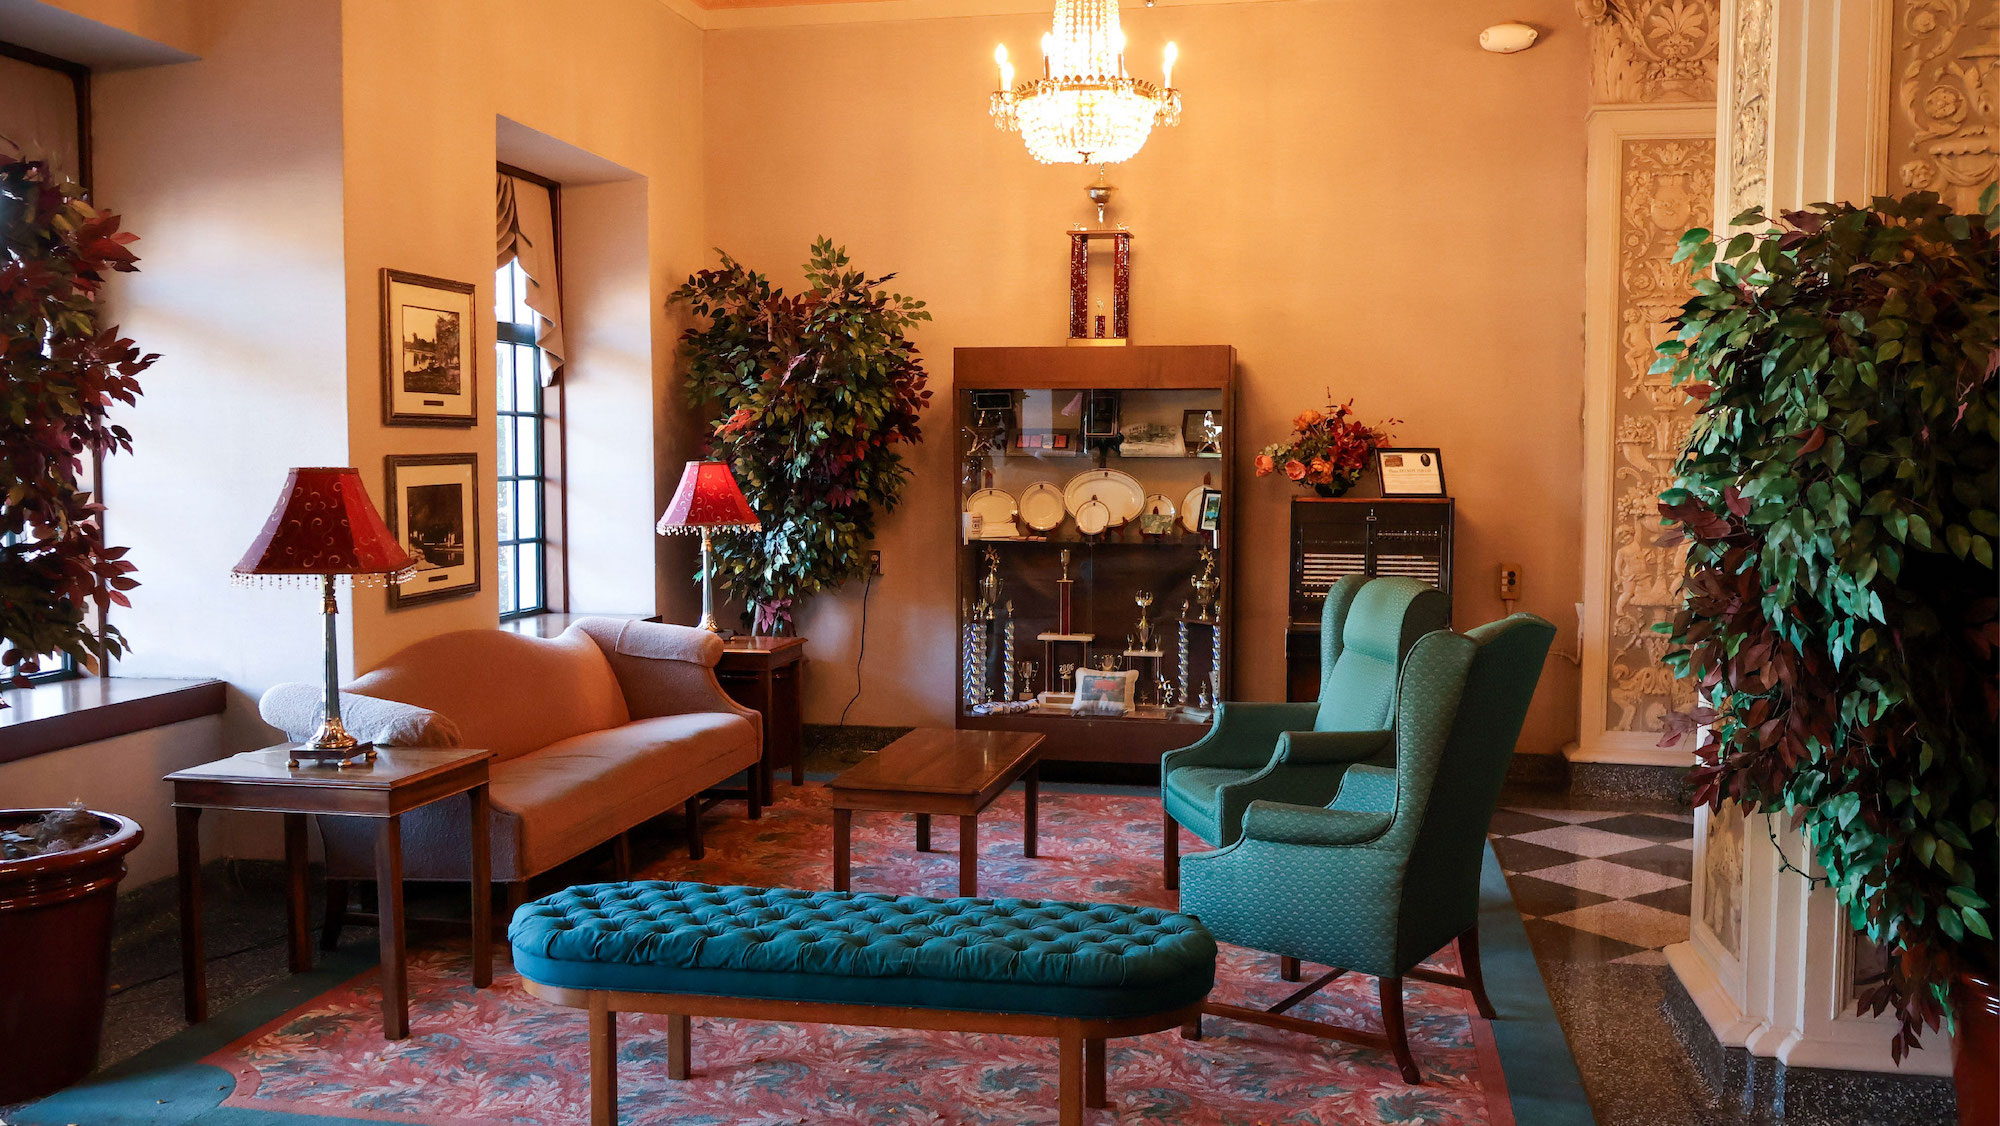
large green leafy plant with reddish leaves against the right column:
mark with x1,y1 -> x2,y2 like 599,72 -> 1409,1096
1654,190 -> 2000,1060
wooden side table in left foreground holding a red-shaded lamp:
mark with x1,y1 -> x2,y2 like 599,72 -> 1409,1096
166,746 -> 494,1040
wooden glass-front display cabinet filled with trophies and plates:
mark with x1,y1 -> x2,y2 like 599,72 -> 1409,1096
950,346 -> 1236,762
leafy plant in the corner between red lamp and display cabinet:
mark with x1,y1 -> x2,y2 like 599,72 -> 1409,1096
668,238 -> 930,632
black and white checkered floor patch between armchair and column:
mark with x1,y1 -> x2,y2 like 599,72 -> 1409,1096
1492,808 -> 1694,966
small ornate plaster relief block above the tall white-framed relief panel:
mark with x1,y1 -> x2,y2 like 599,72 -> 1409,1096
1576,0 -> 1720,104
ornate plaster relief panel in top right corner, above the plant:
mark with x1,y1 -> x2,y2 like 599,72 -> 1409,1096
1888,0 -> 2000,212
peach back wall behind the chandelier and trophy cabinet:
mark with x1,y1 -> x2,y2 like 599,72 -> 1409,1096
704,0 -> 1586,754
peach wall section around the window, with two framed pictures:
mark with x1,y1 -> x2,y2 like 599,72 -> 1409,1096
342,0 -> 704,668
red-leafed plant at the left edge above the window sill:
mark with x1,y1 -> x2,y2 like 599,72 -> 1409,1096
0,156 -> 156,696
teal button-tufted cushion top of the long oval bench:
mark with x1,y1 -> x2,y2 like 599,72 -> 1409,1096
508,880 -> 1216,1018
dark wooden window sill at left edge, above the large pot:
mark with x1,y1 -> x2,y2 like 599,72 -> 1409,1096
0,676 -> 228,764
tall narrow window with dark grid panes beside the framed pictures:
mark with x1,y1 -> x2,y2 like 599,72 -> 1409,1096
494,258 -> 548,618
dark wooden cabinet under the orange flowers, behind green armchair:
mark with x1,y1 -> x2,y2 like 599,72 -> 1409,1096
1284,496 -> 1452,700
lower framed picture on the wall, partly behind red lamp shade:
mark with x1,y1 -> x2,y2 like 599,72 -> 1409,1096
384,454 -> 480,610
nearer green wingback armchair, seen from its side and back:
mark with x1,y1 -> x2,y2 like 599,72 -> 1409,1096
1180,614 -> 1556,1084
